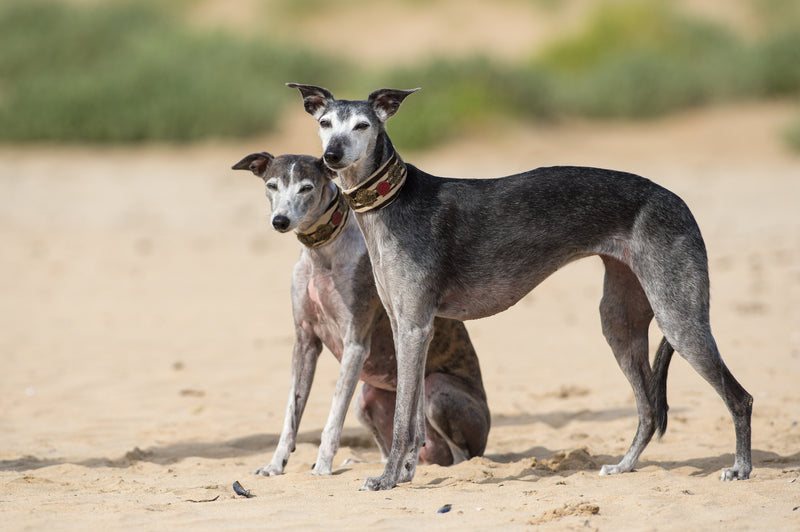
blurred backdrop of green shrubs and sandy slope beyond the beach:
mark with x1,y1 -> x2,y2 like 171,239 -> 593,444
0,0 -> 800,150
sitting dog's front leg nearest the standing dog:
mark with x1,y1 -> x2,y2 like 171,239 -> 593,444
312,335 -> 370,475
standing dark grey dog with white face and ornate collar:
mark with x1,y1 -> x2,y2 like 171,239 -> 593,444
288,83 -> 753,490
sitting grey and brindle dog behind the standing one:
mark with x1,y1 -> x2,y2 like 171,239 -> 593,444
233,152 -> 489,476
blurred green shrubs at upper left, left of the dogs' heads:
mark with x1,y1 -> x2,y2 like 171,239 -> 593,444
0,0 -> 346,142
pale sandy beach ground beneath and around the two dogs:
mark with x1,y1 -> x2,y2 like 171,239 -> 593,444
0,104 -> 800,530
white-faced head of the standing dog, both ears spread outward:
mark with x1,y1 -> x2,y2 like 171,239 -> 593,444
286,83 -> 419,171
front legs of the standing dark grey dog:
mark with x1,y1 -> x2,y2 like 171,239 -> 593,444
361,315 -> 433,491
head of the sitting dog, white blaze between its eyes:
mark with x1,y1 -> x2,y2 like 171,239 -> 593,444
233,152 -> 337,233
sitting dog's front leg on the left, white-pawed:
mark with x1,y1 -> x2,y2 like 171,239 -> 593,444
255,325 -> 322,477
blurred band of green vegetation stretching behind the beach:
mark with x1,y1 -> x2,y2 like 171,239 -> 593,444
0,0 -> 800,149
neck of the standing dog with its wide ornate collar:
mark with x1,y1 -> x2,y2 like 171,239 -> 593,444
339,132 -> 408,213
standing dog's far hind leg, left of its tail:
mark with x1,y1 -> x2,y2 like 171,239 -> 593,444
600,256 -> 656,475
